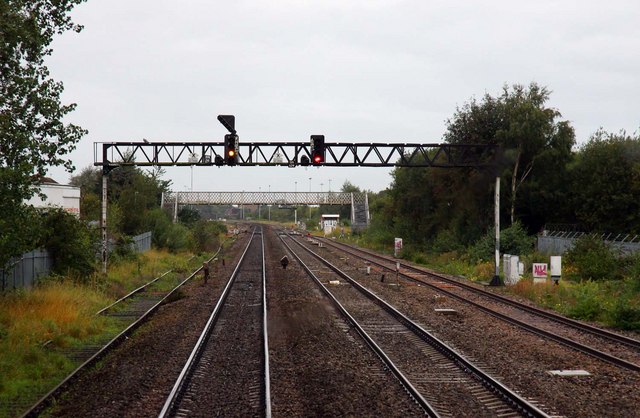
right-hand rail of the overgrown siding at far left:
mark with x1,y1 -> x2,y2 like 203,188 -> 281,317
22,246 -> 222,418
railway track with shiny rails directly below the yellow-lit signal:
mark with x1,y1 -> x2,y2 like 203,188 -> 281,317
159,227 -> 271,417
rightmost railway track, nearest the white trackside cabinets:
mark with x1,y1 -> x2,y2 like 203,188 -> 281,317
314,238 -> 640,371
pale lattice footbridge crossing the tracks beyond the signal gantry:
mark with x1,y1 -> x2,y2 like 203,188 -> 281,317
162,191 -> 369,228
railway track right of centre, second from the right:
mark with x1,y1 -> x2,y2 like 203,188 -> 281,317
281,232 -> 548,417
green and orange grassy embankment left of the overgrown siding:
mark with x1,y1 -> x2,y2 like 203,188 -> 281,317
0,250 -> 203,417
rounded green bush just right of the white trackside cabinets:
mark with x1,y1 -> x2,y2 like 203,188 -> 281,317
565,235 -> 622,280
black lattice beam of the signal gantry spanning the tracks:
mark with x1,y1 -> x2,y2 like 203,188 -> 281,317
94,142 -> 497,171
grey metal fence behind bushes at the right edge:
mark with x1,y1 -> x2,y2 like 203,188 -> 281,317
537,231 -> 640,255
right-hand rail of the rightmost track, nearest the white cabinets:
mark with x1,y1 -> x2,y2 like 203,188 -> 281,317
318,237 -> 640,349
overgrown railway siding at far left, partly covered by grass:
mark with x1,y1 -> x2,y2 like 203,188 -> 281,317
22,245 -> 222,417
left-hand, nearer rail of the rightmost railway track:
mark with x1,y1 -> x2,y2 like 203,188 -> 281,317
316,237 -> 640,372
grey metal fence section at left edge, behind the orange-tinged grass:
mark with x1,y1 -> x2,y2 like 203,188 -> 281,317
0,250 -> 53,291
